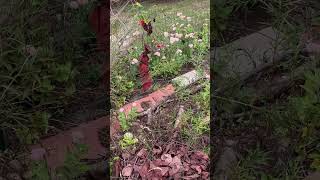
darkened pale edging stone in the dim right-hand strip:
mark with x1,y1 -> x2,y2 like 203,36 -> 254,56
214,27 -> 284,77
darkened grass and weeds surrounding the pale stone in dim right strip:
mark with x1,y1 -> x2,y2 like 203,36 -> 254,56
211,0 -> 320,179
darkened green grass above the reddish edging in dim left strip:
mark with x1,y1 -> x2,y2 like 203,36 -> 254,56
0,0 -> 99,143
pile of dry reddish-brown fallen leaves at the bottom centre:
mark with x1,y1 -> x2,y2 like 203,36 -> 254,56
114,144 -> 209,180
